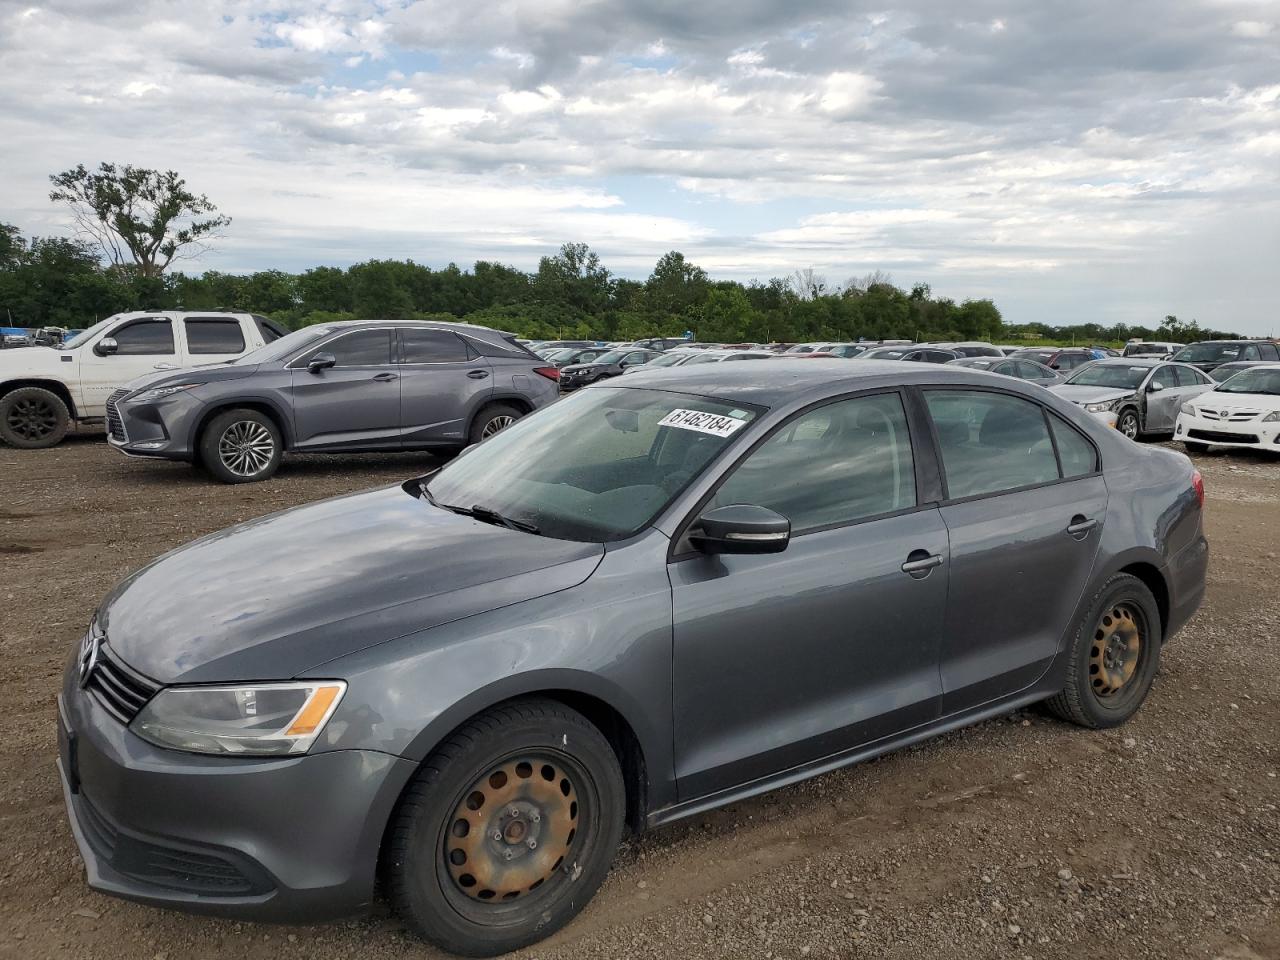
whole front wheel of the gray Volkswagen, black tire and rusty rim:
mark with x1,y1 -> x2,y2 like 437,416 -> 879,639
387,699 -> 626,956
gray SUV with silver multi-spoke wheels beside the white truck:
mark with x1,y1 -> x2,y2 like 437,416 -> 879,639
106,320 -> 559,484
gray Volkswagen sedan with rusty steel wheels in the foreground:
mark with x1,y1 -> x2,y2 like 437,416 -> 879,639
59,360 -> 1207,956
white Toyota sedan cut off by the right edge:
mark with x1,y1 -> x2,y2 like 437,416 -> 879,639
1174,364 -> 1280,453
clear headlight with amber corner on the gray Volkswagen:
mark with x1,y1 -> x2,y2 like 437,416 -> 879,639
132,680 -> 347,755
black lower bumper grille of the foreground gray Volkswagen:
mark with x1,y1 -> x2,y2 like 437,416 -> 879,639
76,791 -> 273,896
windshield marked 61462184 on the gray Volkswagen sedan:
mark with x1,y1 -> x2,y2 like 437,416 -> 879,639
426,387 -> 759,543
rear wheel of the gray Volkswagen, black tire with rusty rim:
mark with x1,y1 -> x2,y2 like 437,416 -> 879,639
1046,573 -> 1164,730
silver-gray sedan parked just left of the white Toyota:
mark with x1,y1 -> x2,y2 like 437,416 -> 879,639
1050,357 -> 1215,440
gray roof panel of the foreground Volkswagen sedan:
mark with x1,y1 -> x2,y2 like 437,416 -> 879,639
609,357 -> 1039,407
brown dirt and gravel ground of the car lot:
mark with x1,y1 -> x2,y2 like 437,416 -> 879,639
0,436 -> 1280,960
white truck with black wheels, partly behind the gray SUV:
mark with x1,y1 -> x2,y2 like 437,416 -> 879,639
0,316 -> 284,449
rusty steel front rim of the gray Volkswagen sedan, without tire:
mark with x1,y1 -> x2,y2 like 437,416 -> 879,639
443,756 -> 579,902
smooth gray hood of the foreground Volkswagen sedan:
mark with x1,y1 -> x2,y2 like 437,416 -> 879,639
97,481 -> 604,684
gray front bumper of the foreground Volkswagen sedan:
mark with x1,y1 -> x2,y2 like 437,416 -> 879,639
58,681 -> 416,922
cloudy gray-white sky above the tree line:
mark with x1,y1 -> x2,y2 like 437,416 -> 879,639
0,0 -> 1280,334
